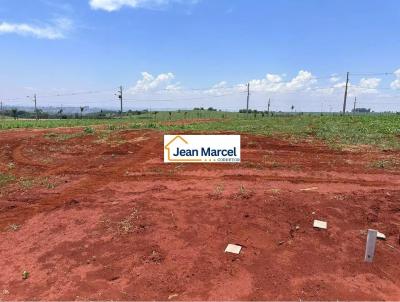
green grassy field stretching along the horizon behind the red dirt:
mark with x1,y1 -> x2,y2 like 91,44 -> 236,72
0,111 -> 400,149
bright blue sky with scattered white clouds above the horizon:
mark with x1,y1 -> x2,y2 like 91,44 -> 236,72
0,0 -> 400,111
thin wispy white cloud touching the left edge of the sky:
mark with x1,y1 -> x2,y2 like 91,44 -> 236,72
0,18 -> 72,40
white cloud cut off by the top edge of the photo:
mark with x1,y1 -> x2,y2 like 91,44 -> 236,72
89,0 -> 198,12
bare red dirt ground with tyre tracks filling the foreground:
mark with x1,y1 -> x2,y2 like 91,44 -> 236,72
0,129 -> 400,300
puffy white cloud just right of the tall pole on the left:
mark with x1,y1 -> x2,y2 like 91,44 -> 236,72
130,71 -> 179,93
